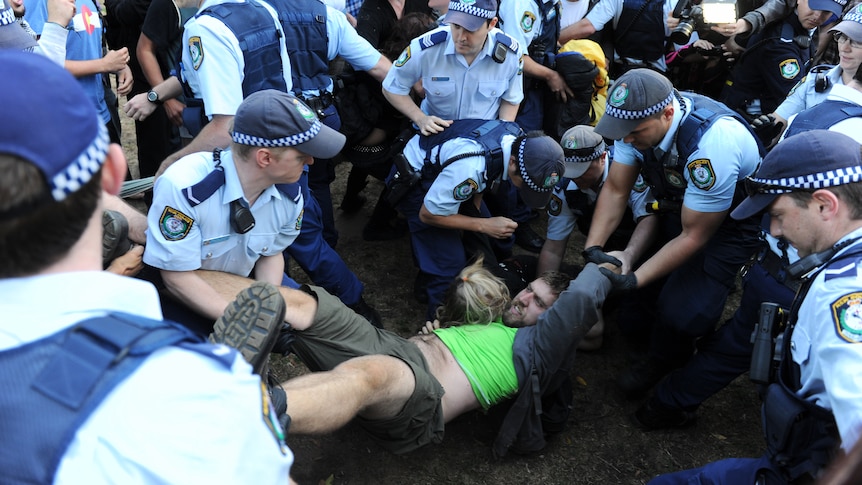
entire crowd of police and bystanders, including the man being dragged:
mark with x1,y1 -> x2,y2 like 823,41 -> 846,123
0,0 -> 862,478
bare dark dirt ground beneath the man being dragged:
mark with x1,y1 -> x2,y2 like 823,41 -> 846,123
123,117 -> 764,485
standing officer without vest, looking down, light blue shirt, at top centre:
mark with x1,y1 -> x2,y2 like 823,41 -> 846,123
383,0 -> 524,135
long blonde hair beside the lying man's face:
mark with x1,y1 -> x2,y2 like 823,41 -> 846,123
436,257 -> 510,326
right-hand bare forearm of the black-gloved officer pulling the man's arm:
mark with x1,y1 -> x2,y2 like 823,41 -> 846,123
635,205 -> 729,288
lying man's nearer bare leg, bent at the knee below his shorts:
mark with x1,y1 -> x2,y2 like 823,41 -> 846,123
281,355 -> 416,434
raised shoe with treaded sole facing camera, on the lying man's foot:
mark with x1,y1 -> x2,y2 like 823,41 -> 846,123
210,281 -> 285,375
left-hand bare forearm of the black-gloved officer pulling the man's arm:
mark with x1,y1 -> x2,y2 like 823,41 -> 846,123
584,163 -> 640,248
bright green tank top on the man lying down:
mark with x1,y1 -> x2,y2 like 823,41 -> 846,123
434,321 -> 518,410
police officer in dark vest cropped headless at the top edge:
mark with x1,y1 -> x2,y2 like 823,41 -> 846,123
560,0 -> 676,74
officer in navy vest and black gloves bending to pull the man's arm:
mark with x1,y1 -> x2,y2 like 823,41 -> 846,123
585,69 -> 761,397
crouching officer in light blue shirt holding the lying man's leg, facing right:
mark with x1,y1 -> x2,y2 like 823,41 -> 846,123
144,90 -> 344,330
